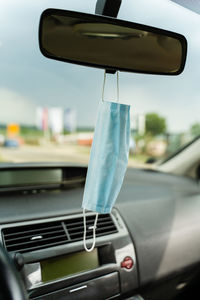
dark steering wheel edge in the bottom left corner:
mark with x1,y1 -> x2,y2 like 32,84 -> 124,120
0,244 -> 28,300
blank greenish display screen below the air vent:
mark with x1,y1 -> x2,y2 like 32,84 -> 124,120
40,249 -> 99,282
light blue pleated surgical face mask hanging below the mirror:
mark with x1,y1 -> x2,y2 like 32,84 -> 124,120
82,101 -> 130,250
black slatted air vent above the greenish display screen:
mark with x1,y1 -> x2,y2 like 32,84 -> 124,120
2,214 -> 117,253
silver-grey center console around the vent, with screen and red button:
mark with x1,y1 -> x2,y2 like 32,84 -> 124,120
1,210 -> 138,300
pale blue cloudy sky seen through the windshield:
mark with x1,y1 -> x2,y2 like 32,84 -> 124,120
0,0 -> 200,132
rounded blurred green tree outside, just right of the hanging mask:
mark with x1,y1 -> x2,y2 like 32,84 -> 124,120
146,113 -> 167,136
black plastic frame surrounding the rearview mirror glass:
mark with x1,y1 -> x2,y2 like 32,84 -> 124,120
39,8 -> 187,75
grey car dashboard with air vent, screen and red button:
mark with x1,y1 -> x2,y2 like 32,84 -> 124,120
0,164 -> 200,300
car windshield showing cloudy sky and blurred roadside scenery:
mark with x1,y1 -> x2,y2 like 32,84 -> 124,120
0,0 -> 200,167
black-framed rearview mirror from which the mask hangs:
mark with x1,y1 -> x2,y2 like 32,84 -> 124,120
39,9 -> 187,75
